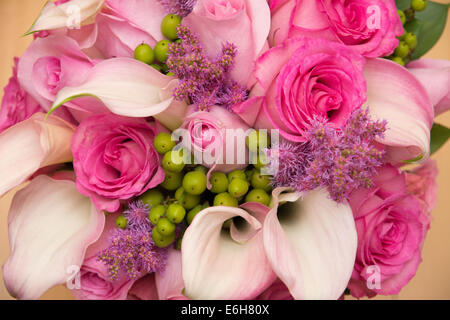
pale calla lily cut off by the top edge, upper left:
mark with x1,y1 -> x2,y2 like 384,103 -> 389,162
26,0 -> 105,35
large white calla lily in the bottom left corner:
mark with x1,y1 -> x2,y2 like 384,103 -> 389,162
3,175 -> 105,299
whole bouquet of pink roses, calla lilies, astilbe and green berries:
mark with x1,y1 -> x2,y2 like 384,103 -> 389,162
0,0 -> 450,300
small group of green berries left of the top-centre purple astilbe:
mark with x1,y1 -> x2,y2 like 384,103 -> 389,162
134,14 -> 181,76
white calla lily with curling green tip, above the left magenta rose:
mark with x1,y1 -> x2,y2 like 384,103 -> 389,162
50,58 -> 185,129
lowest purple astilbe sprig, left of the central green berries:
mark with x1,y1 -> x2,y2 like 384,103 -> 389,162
97,201 -> 167,280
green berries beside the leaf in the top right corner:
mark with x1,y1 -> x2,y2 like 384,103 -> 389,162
389,0 -> 427,66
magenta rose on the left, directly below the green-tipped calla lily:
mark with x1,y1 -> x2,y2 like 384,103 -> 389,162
72,114 -> 164,212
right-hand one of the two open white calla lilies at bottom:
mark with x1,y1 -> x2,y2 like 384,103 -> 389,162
263,188 -> 357,299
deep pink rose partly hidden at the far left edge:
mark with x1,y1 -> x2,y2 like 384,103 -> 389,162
0,58 -> 42,133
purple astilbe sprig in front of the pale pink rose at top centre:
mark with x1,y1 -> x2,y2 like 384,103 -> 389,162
167,26 -> 247,110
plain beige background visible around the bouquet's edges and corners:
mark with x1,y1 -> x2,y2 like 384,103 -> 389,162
0,0 -> 450,299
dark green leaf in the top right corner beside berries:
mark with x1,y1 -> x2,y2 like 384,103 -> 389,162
397,0 -> 449,60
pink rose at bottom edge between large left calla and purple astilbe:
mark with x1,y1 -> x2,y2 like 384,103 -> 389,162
72,214 -> 135,300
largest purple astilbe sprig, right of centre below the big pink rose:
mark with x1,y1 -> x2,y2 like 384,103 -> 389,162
269,108 -> 387,202
